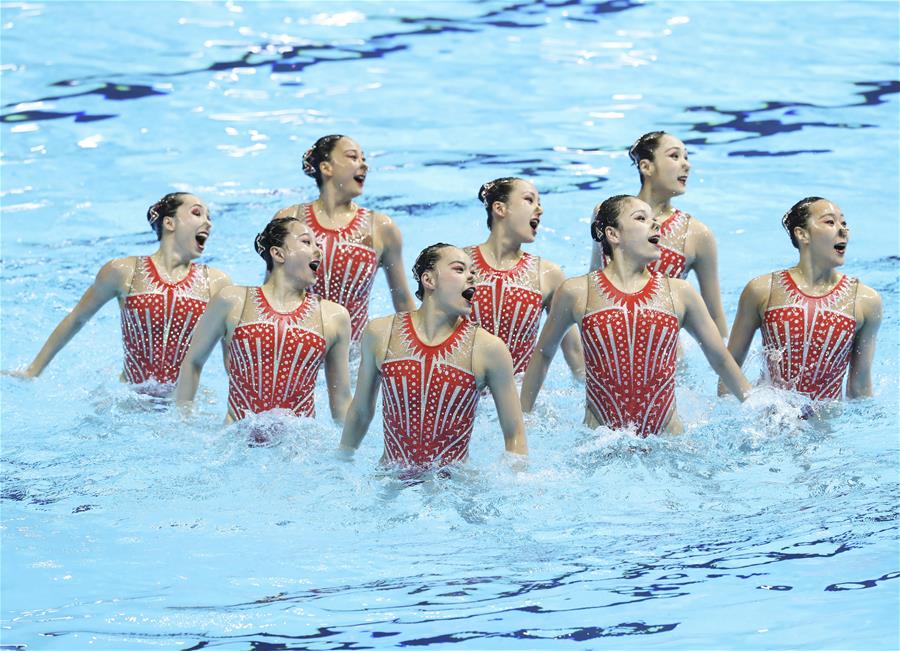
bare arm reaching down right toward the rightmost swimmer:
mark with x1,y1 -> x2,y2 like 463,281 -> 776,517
669,278 -> 751,401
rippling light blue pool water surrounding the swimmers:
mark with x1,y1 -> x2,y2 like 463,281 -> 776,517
0,0 -> 900,650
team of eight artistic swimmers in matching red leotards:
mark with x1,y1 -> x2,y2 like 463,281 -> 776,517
15,131 -> 881,466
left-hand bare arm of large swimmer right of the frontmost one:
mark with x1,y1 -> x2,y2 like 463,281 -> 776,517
520,276 -> 587,413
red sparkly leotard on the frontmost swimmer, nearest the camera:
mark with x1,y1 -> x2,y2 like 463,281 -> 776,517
381,312 -> 479,465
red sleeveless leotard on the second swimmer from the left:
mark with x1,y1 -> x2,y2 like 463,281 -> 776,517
228,287 -> 325,420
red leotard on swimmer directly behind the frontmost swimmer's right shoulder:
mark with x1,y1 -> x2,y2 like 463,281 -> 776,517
465,246 -> 542,373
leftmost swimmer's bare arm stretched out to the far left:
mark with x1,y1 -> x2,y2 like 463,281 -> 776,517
11,257 -> 135,378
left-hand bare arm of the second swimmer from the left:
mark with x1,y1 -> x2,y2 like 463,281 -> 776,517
175,285 -> 247,411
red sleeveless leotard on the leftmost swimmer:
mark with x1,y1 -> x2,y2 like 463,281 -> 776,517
121,256 -> 209,384
